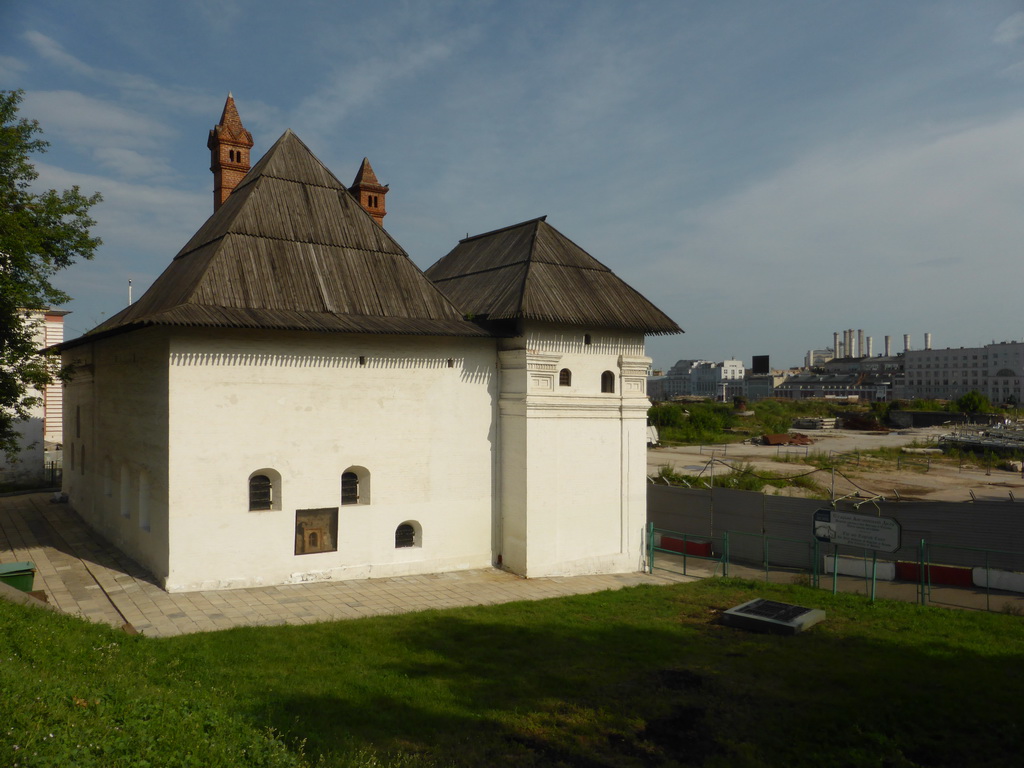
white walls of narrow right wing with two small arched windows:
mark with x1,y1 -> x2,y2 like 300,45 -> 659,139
500,324 -> 650,577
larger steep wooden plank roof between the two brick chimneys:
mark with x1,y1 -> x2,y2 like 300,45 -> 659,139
75,131 -> 486,346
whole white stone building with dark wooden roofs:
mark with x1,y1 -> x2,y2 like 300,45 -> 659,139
56,102 -> 680,591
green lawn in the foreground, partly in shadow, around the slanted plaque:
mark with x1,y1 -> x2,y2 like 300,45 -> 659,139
0,580 -> 1024,767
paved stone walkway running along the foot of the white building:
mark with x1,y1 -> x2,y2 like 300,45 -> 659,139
0,494 -> 694,637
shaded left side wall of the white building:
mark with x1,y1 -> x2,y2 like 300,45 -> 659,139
63,329 -> 168,580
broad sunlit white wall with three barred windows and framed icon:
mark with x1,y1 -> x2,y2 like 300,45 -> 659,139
165,330 -> 497,591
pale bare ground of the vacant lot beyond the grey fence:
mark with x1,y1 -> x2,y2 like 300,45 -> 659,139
647,427 -> 1024,502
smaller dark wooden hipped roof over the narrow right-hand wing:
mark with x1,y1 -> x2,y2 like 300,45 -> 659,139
426,216 -> 683,335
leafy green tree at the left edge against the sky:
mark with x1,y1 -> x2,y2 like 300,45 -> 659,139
0,91 -> 100,457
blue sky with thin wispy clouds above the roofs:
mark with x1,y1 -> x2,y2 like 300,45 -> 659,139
0,0 -> 1024,367
